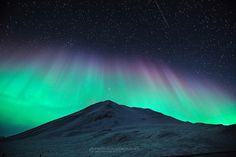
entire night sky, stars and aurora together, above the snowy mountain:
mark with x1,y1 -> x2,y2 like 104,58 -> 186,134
0,0 -> 236,137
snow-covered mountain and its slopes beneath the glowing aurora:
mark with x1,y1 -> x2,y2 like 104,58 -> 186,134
0,100 -> 236,157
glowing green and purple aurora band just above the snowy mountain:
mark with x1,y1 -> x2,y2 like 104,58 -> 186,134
0,52 -> 236,136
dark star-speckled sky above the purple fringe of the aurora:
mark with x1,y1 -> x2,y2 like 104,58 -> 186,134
0,0 -> 236,86
